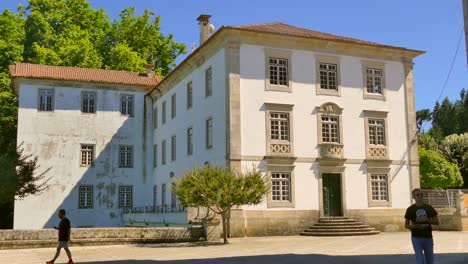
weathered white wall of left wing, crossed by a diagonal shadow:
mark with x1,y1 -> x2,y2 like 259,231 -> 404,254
14,82 -> 152,229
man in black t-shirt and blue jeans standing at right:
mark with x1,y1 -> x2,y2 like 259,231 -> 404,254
405,188 -> 439,264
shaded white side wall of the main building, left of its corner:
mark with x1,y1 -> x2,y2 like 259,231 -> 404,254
151,49 -> 226,210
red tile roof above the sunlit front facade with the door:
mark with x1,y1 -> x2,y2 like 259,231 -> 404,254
223,22 -> 424,53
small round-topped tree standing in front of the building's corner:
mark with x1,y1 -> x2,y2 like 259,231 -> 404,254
173,166 -> 267,244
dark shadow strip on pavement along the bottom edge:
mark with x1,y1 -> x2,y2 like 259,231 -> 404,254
80,253 -> 468,264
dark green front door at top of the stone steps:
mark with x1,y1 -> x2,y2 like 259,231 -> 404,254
322,173 -> 342,216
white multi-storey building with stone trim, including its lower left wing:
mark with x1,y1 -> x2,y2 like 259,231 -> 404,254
12,15 -> 423,235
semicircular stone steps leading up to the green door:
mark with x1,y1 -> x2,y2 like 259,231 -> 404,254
301,216 -> 380,236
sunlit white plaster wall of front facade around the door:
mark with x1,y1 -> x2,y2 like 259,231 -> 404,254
240,44 -> 410,209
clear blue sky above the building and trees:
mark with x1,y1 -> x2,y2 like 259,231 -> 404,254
0,0 -> 468,110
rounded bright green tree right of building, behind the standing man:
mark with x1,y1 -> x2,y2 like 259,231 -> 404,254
419,146 -> 463,188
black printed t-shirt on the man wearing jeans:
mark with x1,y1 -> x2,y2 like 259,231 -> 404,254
405,204 -> 437,238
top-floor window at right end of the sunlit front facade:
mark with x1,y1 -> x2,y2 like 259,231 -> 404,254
362,61 -> 385,100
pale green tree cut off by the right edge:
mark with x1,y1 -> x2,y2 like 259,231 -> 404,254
440,133 -> 468,187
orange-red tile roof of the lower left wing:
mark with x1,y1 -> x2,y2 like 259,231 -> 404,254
10,63 -> 160,89
